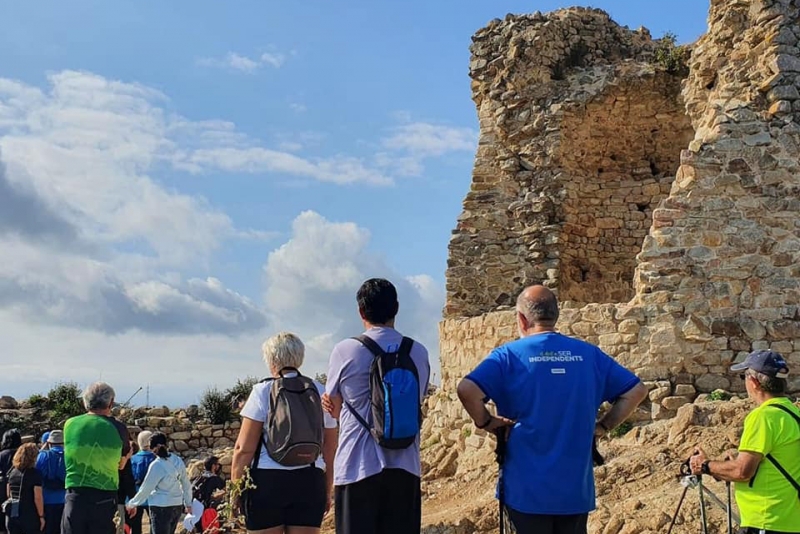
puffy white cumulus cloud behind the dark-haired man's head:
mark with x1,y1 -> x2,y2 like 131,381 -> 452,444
264,211 -> 444,382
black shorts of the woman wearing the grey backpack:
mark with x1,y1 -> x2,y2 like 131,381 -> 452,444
244,466 -> 328,530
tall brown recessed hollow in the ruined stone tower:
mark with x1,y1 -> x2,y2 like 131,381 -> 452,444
559,72 -> 694,303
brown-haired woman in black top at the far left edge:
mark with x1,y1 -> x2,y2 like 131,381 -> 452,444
5,443 -> 44,534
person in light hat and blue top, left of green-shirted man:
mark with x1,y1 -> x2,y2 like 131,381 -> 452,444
36,430 -> 67,534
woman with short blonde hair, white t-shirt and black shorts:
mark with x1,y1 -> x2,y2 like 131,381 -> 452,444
231,332 -> 337,534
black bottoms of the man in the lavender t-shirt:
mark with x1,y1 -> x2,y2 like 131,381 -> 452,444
336,469 -> 422,534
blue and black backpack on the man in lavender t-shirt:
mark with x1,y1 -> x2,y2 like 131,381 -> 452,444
344,335 -> 422,449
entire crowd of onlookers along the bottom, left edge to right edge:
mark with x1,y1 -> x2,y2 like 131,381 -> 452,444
0,279 -> 800,534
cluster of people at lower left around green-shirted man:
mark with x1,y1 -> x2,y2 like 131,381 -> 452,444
0,390 -> 225,534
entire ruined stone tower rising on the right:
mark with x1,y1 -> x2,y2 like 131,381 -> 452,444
425,0 -> 800,461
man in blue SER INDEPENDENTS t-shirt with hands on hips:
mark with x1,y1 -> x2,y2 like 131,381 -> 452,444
458,285 -> 647,534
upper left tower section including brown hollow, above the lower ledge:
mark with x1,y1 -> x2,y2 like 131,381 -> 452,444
445,8 -> 692,317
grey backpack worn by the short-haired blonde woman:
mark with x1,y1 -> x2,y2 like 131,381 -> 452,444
255,368 -> 324,467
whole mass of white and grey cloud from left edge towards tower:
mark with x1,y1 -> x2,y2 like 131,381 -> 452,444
0,71 -> 447,402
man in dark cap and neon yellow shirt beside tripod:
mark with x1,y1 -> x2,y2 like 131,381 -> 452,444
689,350 -> 800,534
